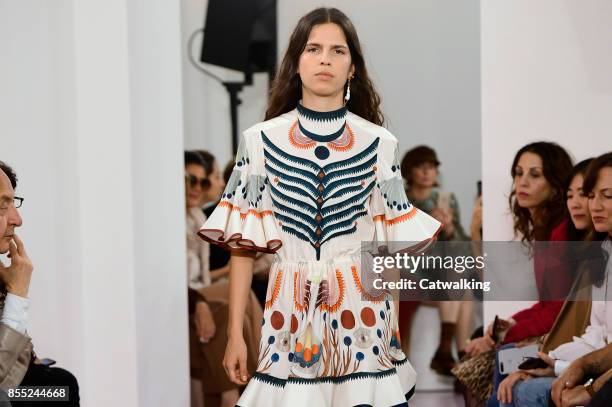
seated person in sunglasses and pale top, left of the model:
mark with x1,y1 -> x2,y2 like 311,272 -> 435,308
185,151 -> 263,407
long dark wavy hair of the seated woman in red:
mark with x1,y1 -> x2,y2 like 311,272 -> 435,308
508,141 -> 573,242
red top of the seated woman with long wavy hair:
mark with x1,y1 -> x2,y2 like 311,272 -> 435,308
503,220 -> 573,344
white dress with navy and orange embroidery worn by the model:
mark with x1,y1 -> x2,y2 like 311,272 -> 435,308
199,105 -> 440,407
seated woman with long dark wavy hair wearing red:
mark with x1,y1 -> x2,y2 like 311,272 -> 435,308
453,142 -> 573,405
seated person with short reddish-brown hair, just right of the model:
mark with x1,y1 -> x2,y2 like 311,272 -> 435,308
399,146 -> 473,375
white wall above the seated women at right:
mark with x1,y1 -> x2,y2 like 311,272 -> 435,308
481,0 -> 612,326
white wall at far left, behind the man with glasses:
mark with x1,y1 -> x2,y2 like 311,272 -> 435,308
0,0 -> 189,407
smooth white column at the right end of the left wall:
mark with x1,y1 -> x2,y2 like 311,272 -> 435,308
125,0 -> 189,407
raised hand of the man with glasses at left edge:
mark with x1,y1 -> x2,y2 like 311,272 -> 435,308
0,235 -> 34,298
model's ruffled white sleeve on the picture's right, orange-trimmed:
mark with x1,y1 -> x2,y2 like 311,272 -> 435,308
370,135 -> 441,253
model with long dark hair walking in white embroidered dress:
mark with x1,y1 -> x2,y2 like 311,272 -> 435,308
200,8 -> 440,407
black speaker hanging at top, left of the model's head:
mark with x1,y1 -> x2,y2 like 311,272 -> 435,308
200,0 -> 277,74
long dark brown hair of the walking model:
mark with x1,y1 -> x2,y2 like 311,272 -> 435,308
266,7 -> 384,126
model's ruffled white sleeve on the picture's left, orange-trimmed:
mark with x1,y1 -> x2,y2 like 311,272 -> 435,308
198,134 -> 282,253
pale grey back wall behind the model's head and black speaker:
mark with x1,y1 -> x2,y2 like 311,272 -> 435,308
181,0 -> 481,230
